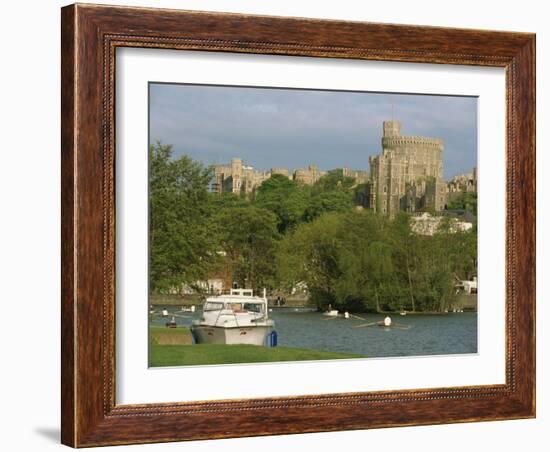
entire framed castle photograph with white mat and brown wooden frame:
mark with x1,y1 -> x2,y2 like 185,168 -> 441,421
61,4 -> 535,447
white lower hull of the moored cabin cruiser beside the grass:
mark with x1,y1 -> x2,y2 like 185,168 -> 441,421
191,325 -> 273,345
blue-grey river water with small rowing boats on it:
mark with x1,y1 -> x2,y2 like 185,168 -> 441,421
151,306 -> 477,357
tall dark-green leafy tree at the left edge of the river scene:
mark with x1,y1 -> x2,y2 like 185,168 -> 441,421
149,142 -> 222,292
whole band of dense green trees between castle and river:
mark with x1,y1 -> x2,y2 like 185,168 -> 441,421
149,143 -> 477,311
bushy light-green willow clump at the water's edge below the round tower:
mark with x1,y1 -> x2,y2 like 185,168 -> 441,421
276,210 -> 477,312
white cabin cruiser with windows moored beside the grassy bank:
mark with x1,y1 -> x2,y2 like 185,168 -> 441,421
191,289 -> 274,345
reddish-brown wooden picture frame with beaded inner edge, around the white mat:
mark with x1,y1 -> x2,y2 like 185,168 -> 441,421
61,4 -> 535,447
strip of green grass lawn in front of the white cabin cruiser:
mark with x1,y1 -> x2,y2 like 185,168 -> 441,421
149,343 -> 364,367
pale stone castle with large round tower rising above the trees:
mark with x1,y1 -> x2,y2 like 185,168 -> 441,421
212,120 -> 477,218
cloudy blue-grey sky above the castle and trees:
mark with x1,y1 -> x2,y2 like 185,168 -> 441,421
149,83 -> 477,180
